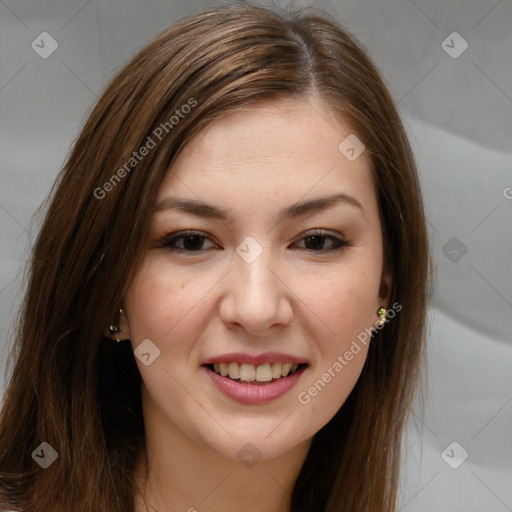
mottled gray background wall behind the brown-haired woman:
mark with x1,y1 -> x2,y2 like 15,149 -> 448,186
0,0 -> 512,512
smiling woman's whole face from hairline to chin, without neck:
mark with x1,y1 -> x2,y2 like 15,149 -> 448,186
124,96 -> 390,459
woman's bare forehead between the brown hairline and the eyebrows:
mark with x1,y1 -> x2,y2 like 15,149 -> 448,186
156,99 -> 375,217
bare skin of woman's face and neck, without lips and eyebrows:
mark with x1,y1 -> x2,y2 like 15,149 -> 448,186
113,99 -> 391,512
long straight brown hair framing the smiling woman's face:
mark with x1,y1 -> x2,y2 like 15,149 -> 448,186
0,4 -> 430,512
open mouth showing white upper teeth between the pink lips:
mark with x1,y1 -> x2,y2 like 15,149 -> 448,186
203,362 -> 308,385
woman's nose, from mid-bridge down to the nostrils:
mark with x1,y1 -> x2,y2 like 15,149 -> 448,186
219,246 -> 293,334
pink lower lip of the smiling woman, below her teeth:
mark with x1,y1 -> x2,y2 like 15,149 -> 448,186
202,366 -> 307,405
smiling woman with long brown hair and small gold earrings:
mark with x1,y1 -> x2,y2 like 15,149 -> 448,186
0,5 -> 430,512
